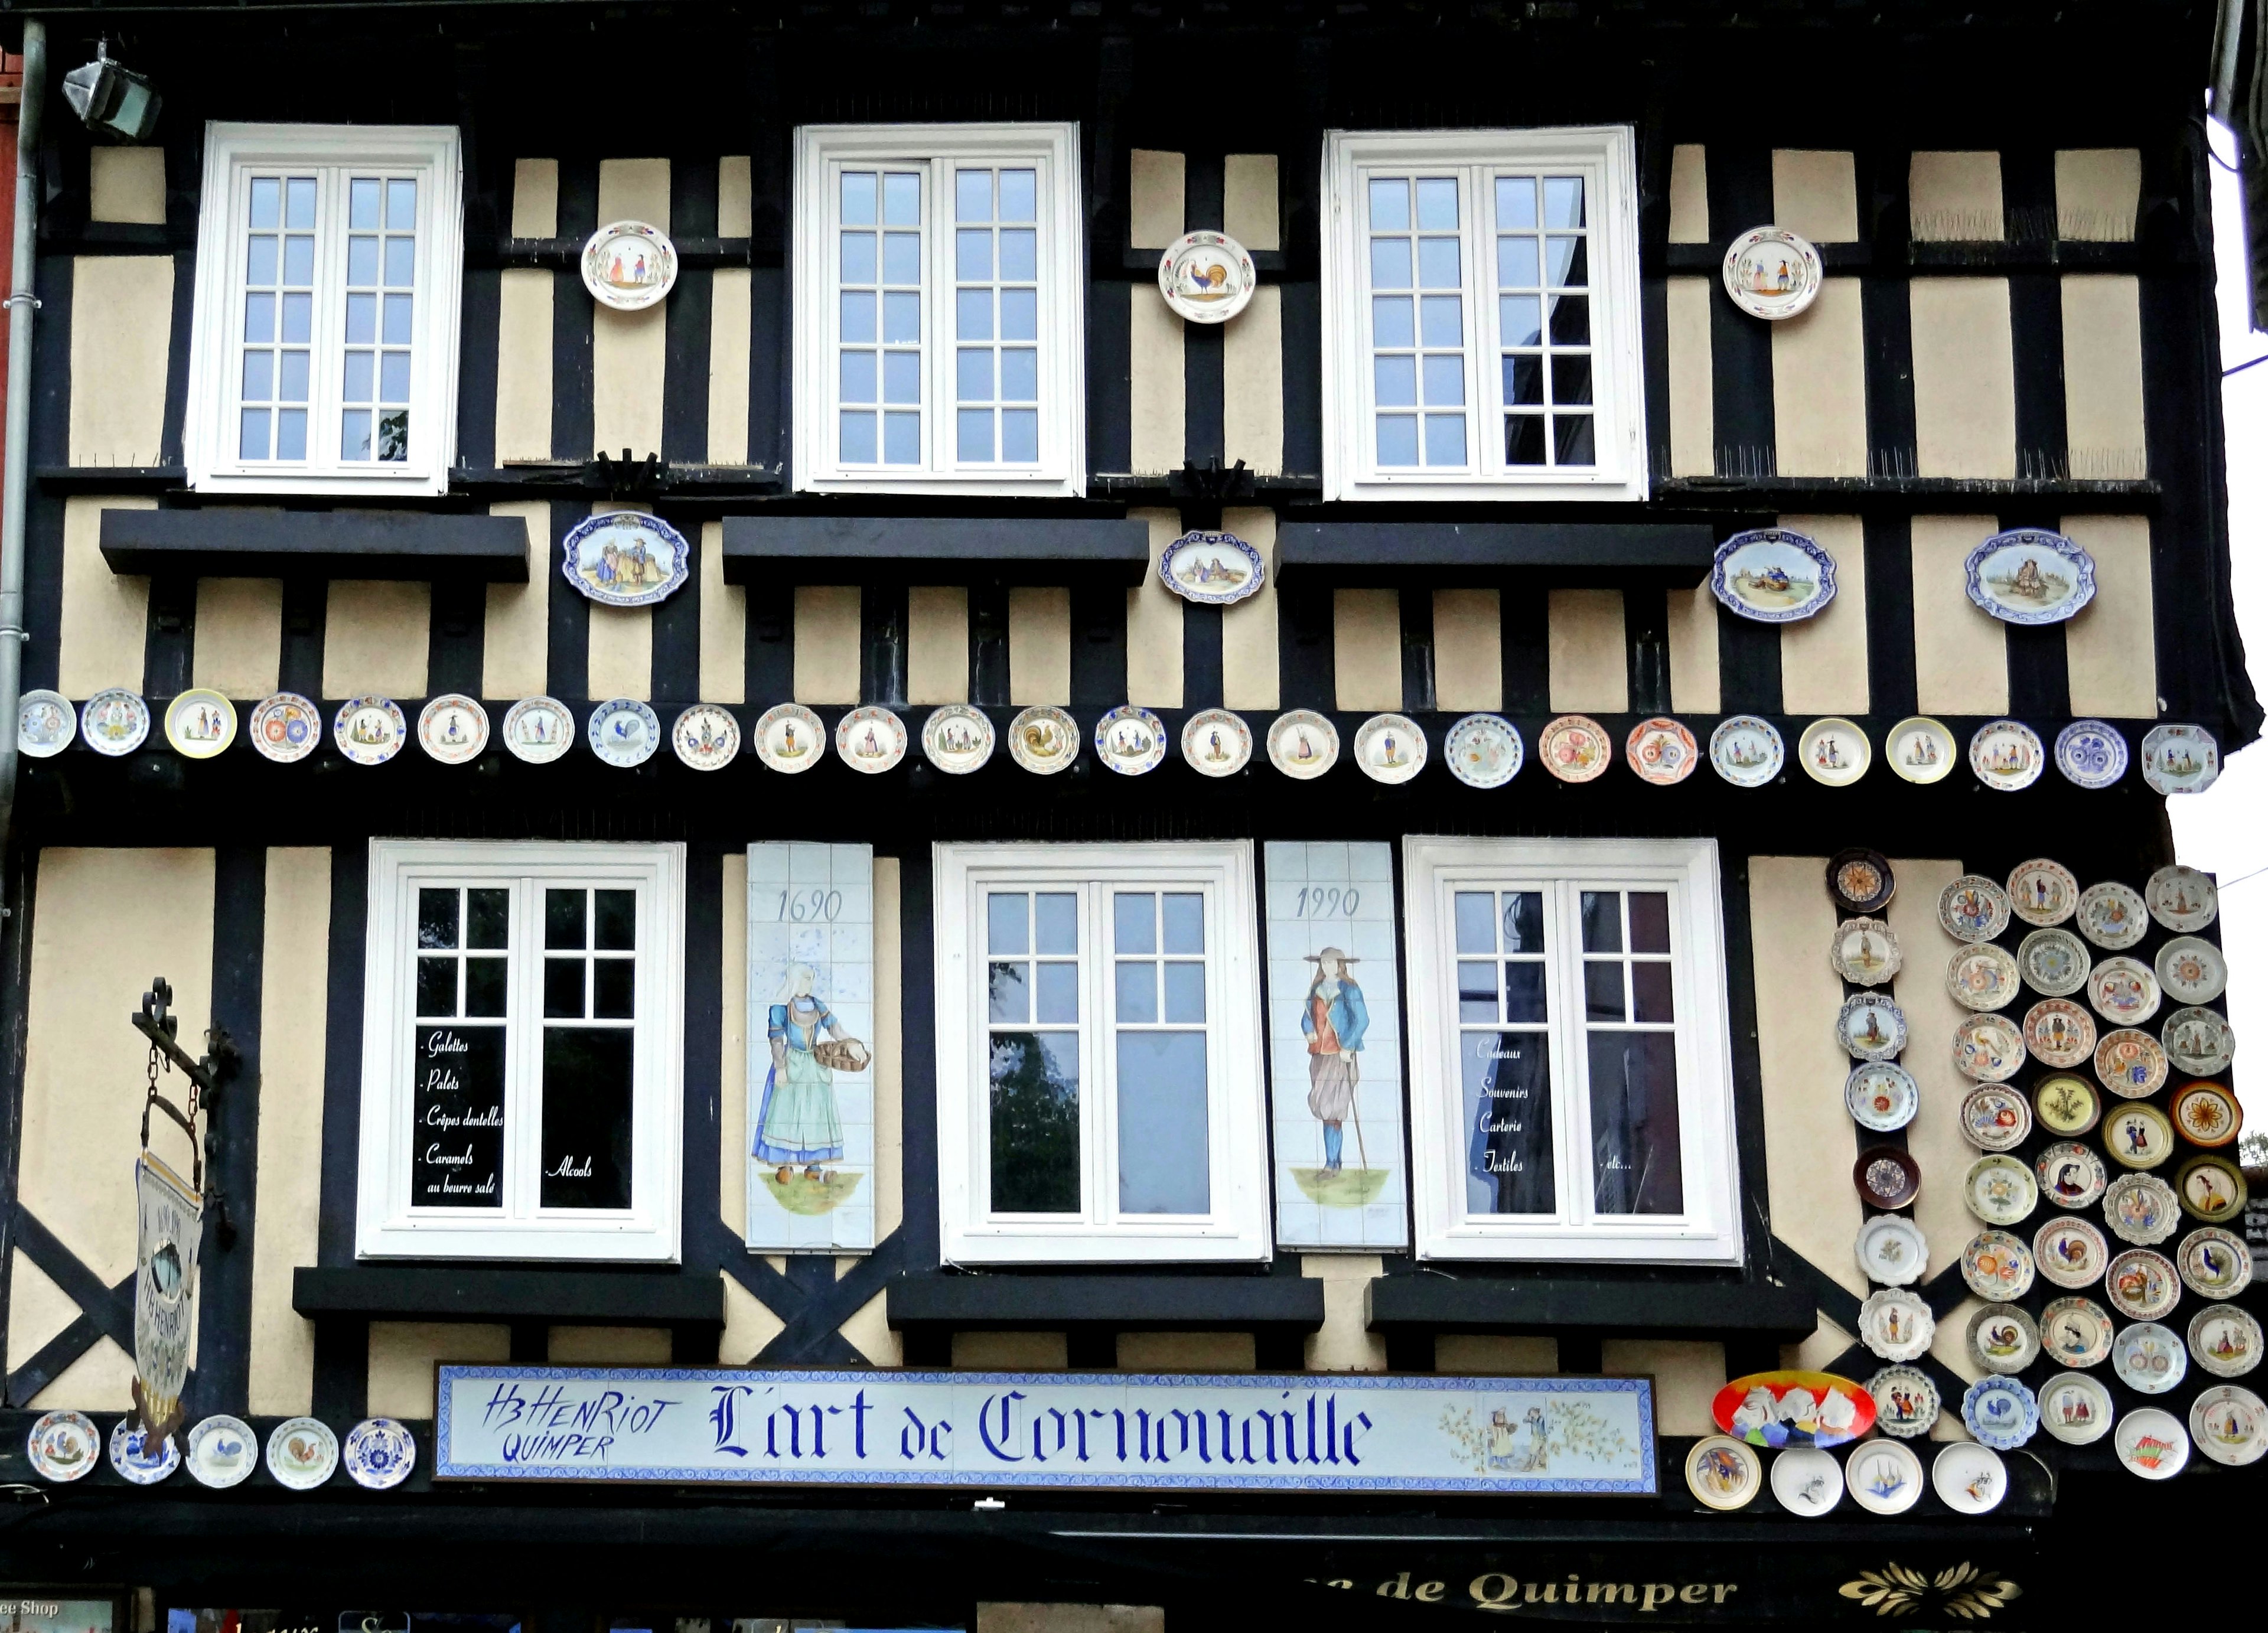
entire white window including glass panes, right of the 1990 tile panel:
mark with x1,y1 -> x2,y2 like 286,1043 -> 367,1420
1409,839 -> 1739,1261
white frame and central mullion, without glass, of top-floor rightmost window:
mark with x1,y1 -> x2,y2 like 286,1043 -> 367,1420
1322,125 -> 1647,501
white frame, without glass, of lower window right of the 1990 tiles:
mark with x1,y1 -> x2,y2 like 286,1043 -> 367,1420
1402,835 -> 1742,1266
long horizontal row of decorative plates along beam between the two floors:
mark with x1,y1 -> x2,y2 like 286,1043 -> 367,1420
16,687 -> 2220,794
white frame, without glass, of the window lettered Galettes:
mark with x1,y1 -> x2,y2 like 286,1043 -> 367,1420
356,839 -> 685,1263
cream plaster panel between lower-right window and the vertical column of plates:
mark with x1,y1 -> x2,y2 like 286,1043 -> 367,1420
1749,855 -> 1859,1298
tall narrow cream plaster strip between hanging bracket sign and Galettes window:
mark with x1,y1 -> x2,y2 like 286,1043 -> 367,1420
249,846 -> 331,1417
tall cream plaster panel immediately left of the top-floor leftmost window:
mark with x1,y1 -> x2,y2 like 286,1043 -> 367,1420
70,256 -> 172,465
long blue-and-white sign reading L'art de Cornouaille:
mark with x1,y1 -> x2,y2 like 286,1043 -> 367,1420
433,1365 -> 1658,1497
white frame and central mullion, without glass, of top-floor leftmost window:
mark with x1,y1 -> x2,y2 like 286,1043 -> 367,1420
181,122 -> 465,494
